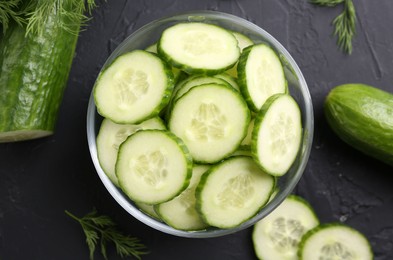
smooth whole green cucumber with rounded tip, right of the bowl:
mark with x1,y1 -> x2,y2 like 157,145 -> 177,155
324,84 -> 393,166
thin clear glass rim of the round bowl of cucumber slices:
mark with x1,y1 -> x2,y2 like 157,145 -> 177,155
86,10 -> 314,238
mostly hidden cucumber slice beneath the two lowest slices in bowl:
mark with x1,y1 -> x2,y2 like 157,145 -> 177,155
155,164 -> 210,231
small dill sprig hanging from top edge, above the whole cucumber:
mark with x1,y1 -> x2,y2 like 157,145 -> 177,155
310,0 -> 356,54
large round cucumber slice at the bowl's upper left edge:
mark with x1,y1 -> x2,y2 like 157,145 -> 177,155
94,50 -> 173,124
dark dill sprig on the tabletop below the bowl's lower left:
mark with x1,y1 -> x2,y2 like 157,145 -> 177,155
65,210 -> 148,260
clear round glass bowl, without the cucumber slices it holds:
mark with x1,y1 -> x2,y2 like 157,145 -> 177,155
87,11 -> 314,238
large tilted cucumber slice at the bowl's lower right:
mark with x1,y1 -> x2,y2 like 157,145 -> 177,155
195,156 -> 275,228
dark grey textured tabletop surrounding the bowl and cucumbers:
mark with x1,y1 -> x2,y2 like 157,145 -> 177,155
0,0 -> 393,260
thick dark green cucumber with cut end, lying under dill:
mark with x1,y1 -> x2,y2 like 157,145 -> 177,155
0,4 -> 80,143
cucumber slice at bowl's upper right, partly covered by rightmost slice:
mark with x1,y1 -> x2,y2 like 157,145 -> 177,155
237,43 -> 287,112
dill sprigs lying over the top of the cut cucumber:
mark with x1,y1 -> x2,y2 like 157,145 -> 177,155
0,0 -> 95,34
